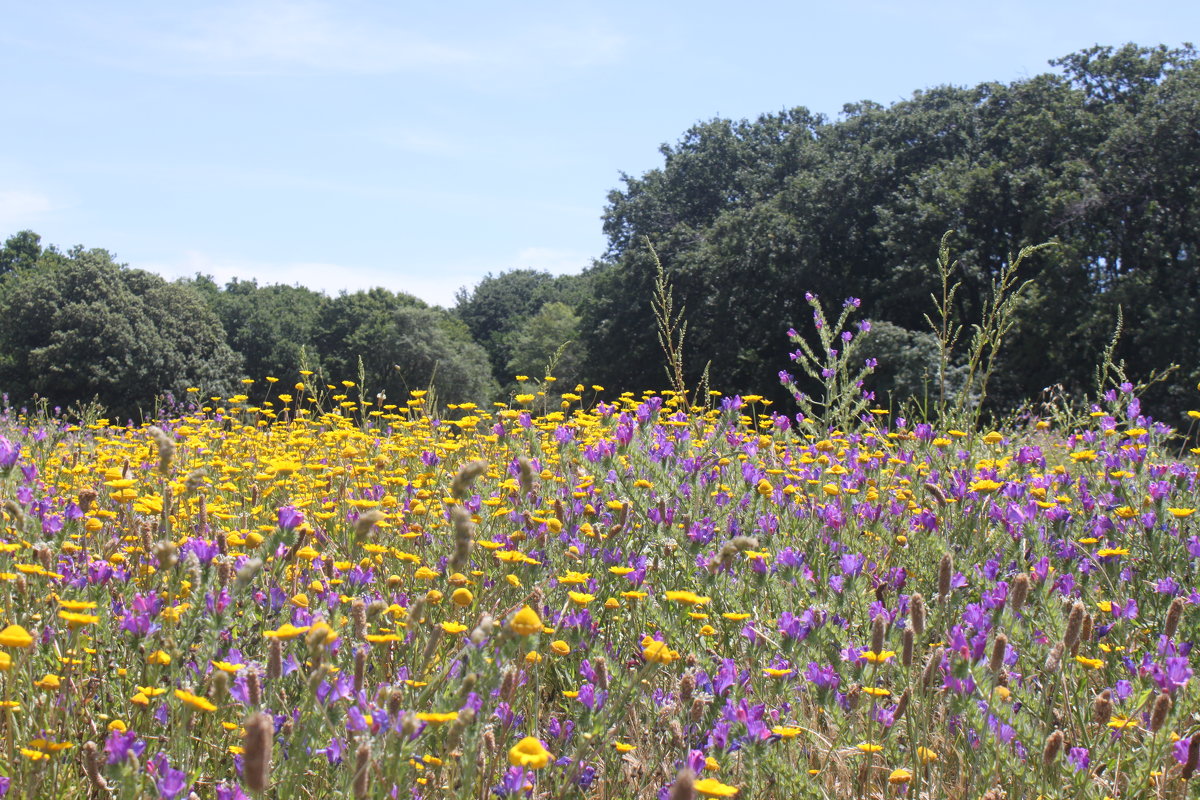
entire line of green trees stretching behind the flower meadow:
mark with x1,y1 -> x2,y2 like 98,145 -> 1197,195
0,44 -> 1200,423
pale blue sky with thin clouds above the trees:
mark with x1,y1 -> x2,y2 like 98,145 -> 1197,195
0,0 -> 1200,305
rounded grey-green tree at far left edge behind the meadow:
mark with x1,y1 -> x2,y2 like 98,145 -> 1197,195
0,240 -> 239,417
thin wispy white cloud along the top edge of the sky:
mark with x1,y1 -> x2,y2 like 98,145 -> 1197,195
108,0 -> 626,80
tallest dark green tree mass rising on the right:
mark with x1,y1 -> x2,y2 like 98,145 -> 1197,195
581,44 -> 1200,431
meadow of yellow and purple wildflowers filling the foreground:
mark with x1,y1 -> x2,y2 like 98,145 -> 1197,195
0,375 -> 1200,800
